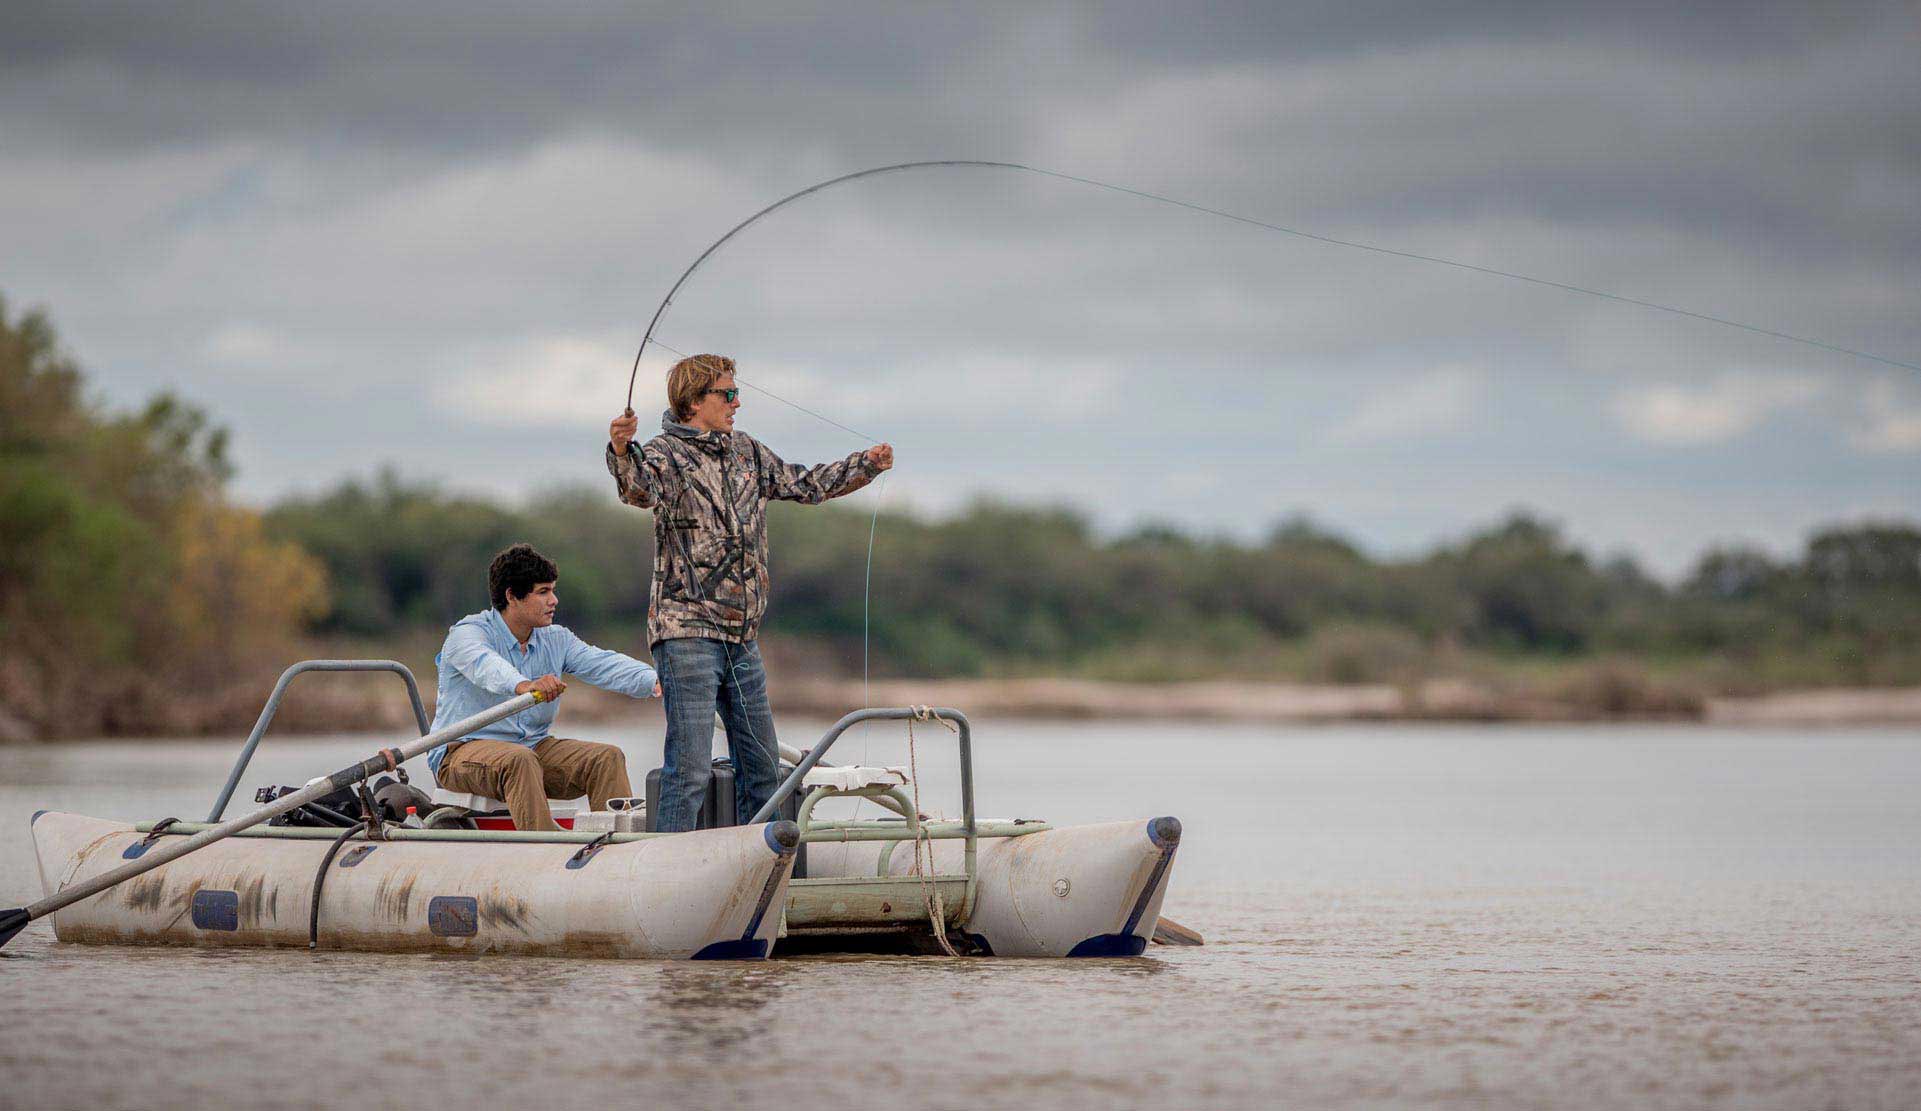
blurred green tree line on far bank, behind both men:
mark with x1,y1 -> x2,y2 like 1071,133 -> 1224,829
267,473 -> 1921,682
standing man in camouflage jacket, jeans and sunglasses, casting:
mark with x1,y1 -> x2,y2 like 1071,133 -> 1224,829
607,356 -> 893,832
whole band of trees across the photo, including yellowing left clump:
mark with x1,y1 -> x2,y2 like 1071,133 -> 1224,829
0,294 -> 1921,734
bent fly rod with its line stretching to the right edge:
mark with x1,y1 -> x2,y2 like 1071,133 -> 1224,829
624,158 -> 1921,417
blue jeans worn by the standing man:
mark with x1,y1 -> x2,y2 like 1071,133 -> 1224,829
653,636 -> 780,832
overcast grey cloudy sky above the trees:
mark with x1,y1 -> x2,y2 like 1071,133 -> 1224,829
0,0 -> 1921,573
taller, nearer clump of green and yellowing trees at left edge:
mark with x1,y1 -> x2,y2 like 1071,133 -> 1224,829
0,302 -> 328,734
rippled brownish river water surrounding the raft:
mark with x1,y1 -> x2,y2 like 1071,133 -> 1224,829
0,721 -> 1921,1109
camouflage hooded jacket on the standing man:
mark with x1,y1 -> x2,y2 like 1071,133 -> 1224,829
607,411 -> 878,646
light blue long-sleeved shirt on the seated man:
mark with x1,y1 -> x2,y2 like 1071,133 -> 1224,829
426,609 -> 659,775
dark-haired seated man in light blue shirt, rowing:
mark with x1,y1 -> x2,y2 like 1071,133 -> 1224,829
426,544 -> 661,830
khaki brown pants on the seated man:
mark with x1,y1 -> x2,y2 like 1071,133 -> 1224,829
434,736 -> 634,830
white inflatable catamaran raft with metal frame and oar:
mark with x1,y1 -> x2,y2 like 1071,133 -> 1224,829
11,661 -> 1179,959
